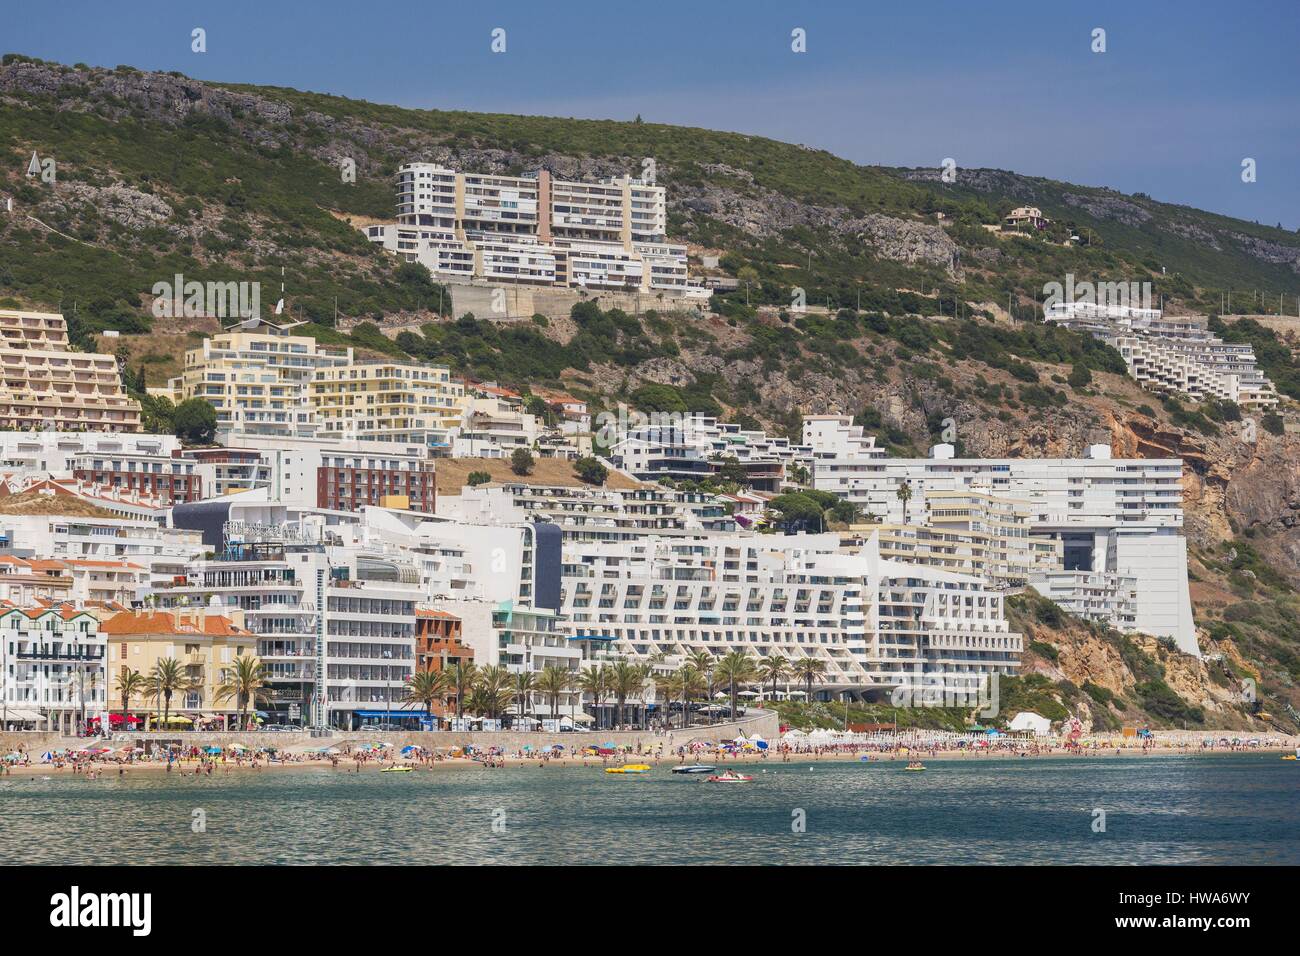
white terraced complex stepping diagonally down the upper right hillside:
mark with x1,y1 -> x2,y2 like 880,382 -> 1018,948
1043,302 -> 1278,408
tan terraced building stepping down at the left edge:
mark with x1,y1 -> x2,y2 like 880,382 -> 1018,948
0,310 -> 140,432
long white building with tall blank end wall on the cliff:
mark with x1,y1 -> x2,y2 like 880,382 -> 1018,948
806,425 -> 1200,656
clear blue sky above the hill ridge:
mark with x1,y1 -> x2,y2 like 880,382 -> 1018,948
0,0 -> 1300,229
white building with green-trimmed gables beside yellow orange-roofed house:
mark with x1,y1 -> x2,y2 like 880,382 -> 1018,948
0,601 -> 111,735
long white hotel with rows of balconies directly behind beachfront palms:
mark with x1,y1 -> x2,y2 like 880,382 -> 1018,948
563,533 -> 1022,697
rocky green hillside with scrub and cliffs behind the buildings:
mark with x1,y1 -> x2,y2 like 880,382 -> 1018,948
0,55 -> 1300,726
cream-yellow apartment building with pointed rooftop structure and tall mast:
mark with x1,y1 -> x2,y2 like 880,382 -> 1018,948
168,319 -> 352,438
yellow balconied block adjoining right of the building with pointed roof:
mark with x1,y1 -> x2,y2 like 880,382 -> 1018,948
311,360 -> 465,445
